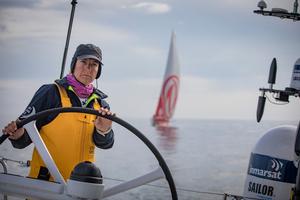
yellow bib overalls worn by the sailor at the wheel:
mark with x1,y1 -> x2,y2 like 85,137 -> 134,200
29,85 -> 100,181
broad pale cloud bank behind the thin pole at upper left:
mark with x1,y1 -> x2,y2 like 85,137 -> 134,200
0,1 -> 135,42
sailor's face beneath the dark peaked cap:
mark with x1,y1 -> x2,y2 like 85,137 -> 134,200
73,58 -> 99,85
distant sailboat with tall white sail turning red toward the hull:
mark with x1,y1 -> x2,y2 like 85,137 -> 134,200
152,32 -> 180,126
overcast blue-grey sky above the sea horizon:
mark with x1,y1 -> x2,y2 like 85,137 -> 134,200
0,0 -> 300,121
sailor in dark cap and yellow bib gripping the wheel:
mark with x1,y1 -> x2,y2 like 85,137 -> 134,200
2,44 -> 114,180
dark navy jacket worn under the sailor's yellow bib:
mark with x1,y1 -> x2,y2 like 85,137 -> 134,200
10,78 -> 114,149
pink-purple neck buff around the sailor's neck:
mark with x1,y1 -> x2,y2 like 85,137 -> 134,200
67,74 -> 94,98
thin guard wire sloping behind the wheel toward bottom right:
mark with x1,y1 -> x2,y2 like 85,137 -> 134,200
103,177 -> 260,200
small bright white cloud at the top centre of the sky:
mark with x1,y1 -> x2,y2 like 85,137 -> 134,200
131,2 -> 171,14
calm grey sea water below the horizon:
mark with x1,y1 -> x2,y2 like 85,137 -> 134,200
0,119 -> 298,200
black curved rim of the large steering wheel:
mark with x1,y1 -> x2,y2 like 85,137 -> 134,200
0,107 -> 178,200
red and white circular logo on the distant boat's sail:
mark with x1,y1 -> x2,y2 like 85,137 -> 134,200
161,75 -> 179,118
